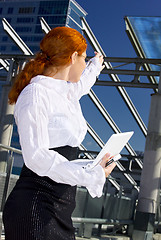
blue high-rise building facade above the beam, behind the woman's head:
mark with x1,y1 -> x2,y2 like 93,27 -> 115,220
0,0 -> 87,54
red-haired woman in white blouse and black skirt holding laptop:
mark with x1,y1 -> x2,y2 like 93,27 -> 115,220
3,27 -> 115,240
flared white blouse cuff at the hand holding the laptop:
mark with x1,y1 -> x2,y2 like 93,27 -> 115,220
86,165 -> 106,198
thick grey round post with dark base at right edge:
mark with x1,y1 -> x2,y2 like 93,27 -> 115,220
132,70 -> 161,240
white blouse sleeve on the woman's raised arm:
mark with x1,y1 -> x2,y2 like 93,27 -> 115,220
74,57 -> 102,99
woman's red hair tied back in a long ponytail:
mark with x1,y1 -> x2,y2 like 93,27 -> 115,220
8,27 -> 87,104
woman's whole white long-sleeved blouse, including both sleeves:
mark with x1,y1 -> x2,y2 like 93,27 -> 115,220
14,57 -> 105,197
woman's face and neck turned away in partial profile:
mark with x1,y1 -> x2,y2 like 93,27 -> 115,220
69,51 -> 87,82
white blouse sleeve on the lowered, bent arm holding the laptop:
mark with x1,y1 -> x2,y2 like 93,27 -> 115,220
15,96 -> 105,197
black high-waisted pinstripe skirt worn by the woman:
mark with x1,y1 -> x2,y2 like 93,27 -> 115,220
3,146 -> 78,240
